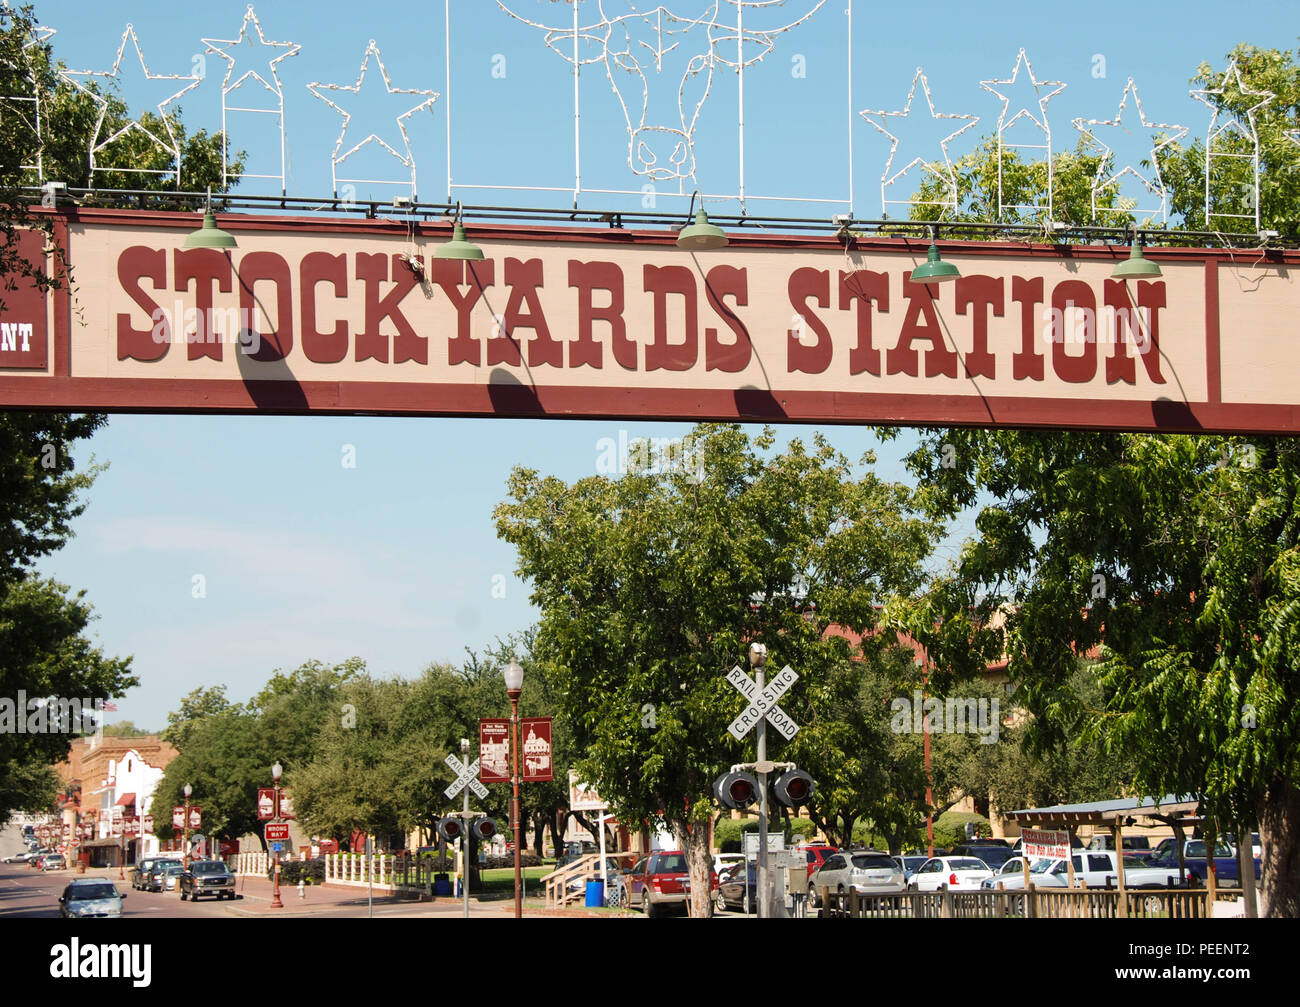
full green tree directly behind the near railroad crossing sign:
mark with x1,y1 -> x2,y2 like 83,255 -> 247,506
497,426 -> 933,916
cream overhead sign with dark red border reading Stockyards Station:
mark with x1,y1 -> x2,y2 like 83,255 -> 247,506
0,209 -> 1300,433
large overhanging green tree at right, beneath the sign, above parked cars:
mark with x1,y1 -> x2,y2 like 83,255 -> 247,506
909,430 -> 1300,916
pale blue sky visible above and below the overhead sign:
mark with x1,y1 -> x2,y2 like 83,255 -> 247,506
22,0 -> 1300,729
